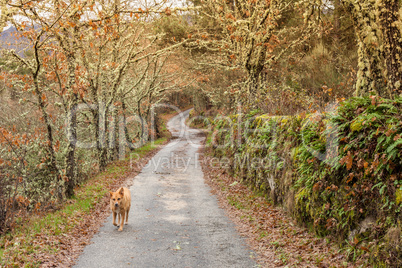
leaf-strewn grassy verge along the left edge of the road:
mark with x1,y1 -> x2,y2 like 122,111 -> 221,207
0,108 -> 187,267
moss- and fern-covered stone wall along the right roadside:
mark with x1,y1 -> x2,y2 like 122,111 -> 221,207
204,96 -> 402,267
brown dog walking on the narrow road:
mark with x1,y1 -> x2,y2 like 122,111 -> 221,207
109,187 -> 131,231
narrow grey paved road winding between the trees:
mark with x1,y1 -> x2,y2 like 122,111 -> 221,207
75,111 -> 258,268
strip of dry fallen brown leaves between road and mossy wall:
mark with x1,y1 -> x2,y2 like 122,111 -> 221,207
201,152 -> 356,267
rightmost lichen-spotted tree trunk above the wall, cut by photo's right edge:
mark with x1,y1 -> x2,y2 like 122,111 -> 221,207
378,0 -> 402,96
